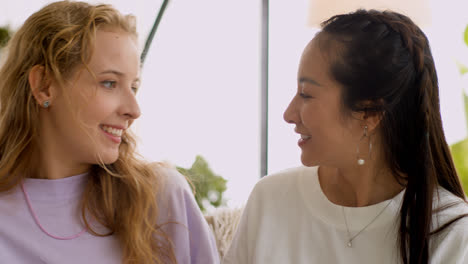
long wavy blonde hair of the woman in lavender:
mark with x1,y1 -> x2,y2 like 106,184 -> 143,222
0,1 -> 176,264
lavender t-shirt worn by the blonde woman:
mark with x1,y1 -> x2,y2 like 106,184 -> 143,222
0,168 -> 219,264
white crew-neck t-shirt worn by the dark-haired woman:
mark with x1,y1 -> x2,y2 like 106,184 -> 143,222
223,167 -> 468,264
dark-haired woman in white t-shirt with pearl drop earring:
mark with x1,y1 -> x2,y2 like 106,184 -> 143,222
224,10 -> 468,264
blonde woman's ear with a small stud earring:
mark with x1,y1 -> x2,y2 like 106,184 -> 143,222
28,65 -> 57,106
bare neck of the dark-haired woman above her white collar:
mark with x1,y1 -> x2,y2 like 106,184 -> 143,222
319,163 -> 403,207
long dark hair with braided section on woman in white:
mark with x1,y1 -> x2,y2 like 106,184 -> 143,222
318,10 -> 465,264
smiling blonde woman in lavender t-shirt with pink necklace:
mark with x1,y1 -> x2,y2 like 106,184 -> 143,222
0,1 -> 219,264
